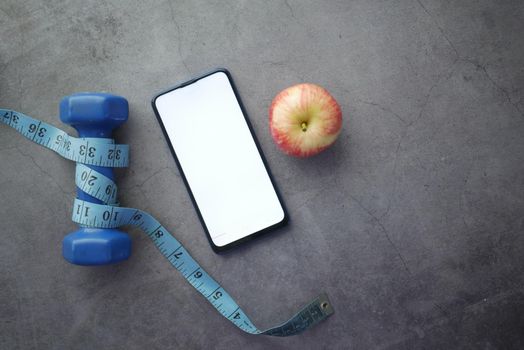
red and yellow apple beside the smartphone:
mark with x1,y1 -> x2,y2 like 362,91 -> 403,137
269,84 -> 342,157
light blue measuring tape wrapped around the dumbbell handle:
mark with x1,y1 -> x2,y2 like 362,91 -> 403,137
0,109 -> 334,336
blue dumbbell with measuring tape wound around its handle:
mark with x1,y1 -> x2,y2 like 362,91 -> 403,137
60,93 -> 131,265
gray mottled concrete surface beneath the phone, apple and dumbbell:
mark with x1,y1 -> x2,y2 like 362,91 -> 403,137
0,0 -> 524,349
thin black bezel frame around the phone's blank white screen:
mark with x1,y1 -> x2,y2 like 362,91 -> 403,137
151,68 -> 289,253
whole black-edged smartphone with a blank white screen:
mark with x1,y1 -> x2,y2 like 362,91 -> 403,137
152,69 -> 288,253
